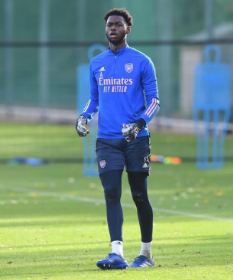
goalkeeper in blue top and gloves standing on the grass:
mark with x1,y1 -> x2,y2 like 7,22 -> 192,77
76,8 -> 159,269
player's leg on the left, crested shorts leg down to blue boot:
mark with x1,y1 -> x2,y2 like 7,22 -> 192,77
96,139 -> 128,269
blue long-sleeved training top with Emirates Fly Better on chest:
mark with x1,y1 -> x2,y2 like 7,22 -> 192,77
81,45 -> 159,139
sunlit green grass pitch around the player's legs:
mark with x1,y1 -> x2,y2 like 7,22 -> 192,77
0,124 -> 233,280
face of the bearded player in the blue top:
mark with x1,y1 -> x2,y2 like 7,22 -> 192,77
105,16 -> 130,45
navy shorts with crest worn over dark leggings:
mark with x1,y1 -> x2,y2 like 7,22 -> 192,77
96,136 -> 151,175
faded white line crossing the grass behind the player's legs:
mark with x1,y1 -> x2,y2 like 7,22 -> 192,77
0,185 -> 233,222
